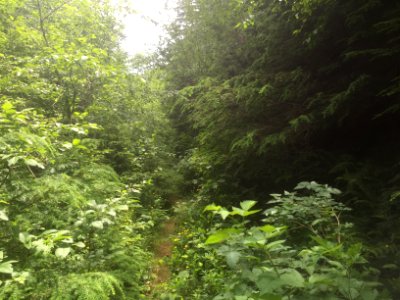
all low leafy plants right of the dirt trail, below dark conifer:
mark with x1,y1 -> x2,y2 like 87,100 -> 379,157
165,182 -> 390,300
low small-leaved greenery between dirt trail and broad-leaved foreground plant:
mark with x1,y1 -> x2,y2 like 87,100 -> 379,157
159,201 -> 226,299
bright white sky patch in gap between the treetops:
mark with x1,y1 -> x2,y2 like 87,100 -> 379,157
116,0 -> 177,56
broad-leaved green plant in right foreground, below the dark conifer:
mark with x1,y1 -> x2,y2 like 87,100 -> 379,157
205,182 -> 389,300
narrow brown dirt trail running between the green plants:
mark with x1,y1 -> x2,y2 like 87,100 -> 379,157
148,217 -> 176,299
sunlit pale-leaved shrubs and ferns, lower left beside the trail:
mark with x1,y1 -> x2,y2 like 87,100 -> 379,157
1,102 -> 153,299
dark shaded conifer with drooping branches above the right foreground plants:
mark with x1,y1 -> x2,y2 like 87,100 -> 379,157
161,0 -> 400,298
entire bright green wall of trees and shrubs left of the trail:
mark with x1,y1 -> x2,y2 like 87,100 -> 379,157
0,0 -> 173,299
